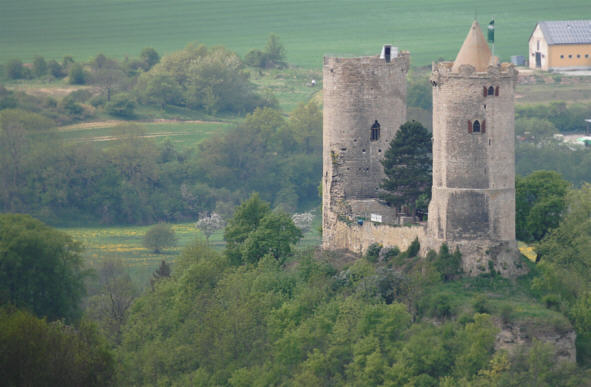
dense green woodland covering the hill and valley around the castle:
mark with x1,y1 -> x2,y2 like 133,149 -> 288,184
0,35 -> 591,386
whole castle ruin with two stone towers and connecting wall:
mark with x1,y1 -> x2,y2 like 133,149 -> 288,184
322,21 -> 523,276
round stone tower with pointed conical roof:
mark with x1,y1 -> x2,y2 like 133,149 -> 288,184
427,21 -> 523,276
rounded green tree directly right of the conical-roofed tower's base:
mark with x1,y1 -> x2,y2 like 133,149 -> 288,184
515,171 -> 569,241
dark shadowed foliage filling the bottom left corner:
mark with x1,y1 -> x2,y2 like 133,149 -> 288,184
0,308 -> 115,386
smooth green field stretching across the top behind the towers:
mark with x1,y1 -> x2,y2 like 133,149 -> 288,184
0,0 -> 589,68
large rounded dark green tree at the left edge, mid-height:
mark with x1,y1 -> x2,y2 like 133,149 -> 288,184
0,214 -> 85,321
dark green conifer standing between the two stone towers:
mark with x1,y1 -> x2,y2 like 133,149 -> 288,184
380,121 -> 432,215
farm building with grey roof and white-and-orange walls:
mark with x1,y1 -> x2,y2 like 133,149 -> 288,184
529,20 -> 591,71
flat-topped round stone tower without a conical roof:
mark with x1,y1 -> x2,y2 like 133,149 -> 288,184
322,45 -> 409,250
